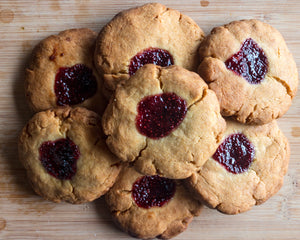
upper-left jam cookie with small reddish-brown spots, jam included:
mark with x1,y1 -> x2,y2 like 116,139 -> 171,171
25,28 -> 107,114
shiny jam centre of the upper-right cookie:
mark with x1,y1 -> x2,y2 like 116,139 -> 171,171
225,38 -> 269,84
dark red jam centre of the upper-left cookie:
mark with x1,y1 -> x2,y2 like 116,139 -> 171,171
54,64 -> 97,106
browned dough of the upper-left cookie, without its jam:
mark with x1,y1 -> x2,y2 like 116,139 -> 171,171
25,28 -> 107,114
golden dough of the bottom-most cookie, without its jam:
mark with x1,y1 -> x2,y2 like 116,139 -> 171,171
105,167 -> 202,239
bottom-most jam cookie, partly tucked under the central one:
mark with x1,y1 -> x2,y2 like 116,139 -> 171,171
105,167 -> 202,239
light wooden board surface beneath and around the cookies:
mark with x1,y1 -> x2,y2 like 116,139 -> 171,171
0,0 -> 300,240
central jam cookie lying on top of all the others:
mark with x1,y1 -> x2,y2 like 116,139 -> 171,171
102,64 -> 225,179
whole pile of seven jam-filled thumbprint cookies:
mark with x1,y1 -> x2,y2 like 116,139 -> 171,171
19,3 -> 298,239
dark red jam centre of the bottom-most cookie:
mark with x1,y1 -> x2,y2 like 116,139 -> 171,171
132,175 -> 176,208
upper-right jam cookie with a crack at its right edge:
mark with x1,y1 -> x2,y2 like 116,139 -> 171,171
198,20 -> 298,124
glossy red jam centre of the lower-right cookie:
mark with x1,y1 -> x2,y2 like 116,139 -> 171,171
213,133 -> 255,174
